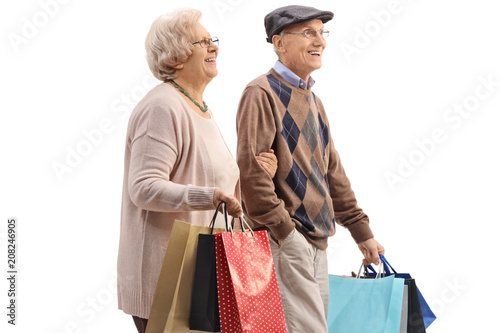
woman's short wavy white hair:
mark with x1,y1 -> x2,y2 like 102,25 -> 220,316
145,8 -> 201,81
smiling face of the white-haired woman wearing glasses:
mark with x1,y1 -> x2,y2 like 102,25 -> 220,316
179,23 -> 219,83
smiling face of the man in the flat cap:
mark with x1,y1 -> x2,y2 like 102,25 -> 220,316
278,19 -> 326,82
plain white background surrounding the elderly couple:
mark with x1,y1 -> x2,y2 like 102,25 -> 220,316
0,0 -> 500,333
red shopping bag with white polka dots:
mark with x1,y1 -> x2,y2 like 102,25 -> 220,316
215,219 -> 287,333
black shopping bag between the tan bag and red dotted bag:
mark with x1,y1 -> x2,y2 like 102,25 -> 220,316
189,201 -> 228,332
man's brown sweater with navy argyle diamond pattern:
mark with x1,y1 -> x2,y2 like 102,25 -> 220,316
237,69 -> 373,249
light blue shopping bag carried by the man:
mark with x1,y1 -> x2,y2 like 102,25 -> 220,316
327,264 -> 404,333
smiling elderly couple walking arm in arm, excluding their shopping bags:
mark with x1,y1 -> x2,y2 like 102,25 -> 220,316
118,6 -> 384,333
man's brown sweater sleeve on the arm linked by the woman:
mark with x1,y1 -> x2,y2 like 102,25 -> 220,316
236,86 -> 295,241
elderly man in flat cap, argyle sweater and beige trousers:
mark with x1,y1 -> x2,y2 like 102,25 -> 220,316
237,6 -> 384,333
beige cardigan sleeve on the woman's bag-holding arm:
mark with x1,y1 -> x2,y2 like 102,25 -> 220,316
128,107 -> 215,212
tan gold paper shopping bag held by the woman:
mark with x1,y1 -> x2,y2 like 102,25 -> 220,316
146,220 -> 224,333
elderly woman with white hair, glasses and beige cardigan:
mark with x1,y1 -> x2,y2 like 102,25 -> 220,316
118,9 -> 277,332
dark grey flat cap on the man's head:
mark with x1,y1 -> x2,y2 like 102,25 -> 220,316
264,6 -> 333,43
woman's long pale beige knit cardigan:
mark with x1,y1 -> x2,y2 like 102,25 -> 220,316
118,83 -> 226,318
